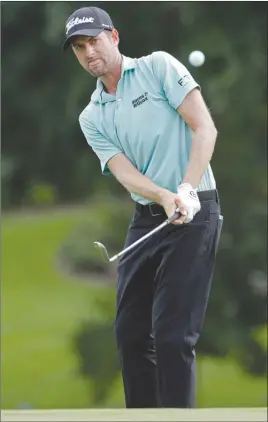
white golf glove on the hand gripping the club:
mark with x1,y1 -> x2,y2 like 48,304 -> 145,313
177,183 -> 201,223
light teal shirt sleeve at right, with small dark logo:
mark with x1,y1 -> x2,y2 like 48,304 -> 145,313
152,51 -> 200,110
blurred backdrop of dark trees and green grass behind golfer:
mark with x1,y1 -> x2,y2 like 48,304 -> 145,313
1,1 -> 267,408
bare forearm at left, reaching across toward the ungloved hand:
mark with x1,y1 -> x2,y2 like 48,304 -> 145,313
108,154 -> 167,204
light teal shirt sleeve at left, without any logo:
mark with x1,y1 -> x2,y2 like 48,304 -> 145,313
79,113 -> 123,175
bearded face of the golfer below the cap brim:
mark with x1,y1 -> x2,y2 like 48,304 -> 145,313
71,29 -> 119,77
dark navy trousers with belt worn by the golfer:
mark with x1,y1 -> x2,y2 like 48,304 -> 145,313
115,191 -> 222,408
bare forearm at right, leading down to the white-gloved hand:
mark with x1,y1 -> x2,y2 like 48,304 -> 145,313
183,127 -> 217,188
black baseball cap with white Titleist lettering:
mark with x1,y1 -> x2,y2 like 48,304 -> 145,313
63,7 -> 114,50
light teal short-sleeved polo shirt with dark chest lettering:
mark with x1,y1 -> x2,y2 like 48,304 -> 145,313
79,51 -> 216,204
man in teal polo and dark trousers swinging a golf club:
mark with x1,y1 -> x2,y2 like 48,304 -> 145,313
64,7 -> 221,408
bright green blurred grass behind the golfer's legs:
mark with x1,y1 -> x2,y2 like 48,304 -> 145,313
1,208 -> 267,409
